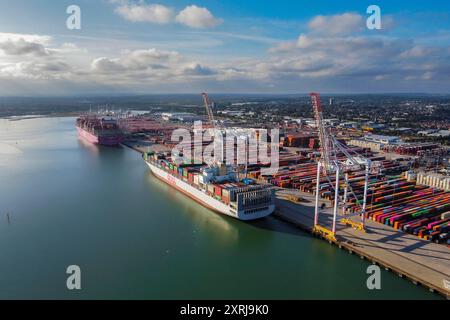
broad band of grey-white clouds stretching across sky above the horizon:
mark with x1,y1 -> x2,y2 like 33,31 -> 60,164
0,11 -> 450,93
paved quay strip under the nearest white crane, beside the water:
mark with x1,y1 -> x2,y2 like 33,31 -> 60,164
274,189 -> 450,299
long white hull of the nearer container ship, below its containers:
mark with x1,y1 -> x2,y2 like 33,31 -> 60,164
146,161 -> 275,220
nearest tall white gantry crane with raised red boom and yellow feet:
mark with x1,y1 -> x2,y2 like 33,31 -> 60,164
310,93 -> 372,241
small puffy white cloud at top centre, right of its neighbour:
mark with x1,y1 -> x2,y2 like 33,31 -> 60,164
176,5 -> 223,29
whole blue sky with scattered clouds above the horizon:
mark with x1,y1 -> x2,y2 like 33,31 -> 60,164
0,0 -> 450,96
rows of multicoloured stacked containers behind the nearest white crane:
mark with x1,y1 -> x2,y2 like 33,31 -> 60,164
249,160 -> 450,245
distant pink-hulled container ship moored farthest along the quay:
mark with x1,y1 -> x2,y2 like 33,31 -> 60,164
76,113 -> 124,146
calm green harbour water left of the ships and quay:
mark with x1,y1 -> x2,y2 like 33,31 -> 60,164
0,118 -> 439,299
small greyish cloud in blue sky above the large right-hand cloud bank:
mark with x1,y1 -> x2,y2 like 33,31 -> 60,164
308,13 -> 365,35
